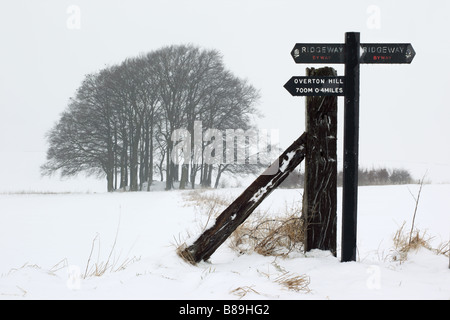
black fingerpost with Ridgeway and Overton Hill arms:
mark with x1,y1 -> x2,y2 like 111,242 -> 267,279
284,32 -> 416,262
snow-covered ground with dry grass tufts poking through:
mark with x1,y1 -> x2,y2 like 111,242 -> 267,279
0,185 -> 450,300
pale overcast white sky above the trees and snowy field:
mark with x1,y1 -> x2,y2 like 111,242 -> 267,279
0,0 -> 450,191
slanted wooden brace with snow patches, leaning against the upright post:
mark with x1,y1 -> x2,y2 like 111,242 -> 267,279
179,133 -> 306,264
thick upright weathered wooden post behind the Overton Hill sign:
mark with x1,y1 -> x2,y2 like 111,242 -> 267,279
303,67 -> 337,256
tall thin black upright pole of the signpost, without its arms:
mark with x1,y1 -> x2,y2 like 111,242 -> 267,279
341,32 -> 360,262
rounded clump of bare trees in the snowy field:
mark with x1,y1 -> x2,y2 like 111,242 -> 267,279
42,45 -> 259,191
